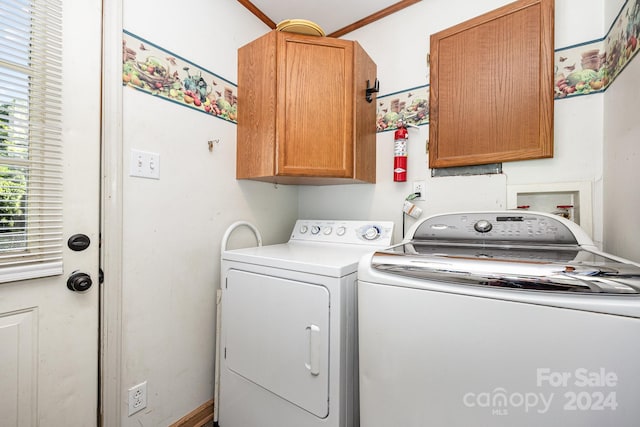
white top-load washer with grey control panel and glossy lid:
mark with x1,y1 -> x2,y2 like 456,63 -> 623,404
358,211 -> 640,427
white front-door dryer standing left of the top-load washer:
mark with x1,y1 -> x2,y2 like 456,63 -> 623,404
217,220 -> 393,427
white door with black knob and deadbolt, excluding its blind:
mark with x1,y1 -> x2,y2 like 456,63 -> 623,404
0,0 -> 102,427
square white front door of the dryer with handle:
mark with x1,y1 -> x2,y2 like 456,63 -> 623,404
222,270 -> 329,418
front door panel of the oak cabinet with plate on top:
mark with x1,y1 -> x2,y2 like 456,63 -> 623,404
276,33 -> 354,177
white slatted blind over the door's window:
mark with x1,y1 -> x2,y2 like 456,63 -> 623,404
0,0 -> 63,283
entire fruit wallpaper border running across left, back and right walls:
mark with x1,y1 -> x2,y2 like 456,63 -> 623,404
122,0 -> 640,132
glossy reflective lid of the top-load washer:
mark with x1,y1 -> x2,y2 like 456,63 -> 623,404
371,243 -> 640,295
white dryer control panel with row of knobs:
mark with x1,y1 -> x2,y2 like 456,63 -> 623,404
289,219 -> 393,247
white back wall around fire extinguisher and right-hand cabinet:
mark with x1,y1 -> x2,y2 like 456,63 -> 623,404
299,0 -> 605,246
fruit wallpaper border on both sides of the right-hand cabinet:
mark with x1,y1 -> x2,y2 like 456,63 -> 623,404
376,0 -> 640,132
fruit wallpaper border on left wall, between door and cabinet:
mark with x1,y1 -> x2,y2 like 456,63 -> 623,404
122,29 -> 238,123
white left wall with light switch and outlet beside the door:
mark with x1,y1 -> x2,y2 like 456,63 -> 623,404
119,0 -> 298,426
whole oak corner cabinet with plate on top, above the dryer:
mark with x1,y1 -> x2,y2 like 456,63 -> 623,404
236,30 -> 377,185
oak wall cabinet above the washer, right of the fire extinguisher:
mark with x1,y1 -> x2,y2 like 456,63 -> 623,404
429,0 -> 554,168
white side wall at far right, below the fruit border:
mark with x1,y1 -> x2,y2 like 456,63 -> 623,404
604,47 -> 640,262
